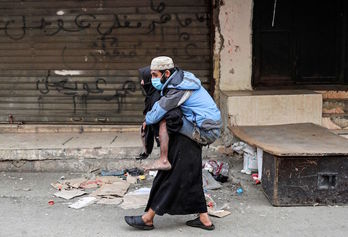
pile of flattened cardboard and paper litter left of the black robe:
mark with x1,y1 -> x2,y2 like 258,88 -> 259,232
51,168 -> 150,209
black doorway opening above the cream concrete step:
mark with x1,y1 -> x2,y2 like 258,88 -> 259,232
253,0 -> 348,90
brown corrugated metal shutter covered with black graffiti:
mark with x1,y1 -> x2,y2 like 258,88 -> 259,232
0,0 -> 212,124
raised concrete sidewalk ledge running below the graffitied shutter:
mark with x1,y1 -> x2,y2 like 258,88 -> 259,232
0,129 -> 218,172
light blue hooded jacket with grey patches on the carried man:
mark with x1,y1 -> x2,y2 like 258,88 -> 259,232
145,69 -> 222,130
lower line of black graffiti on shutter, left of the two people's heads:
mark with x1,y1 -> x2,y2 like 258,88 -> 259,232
36,70 -> 136,114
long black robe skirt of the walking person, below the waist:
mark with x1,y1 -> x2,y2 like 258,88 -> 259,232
145,133 -> 207,215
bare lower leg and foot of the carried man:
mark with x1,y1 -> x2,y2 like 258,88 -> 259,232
145,119 -> 172,170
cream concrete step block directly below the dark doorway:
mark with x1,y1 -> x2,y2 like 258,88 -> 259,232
221,91 -> 322,126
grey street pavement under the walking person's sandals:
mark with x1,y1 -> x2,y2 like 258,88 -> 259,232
0,158 -> 348,237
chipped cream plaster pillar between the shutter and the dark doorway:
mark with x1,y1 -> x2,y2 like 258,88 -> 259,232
215,0 -> 253,91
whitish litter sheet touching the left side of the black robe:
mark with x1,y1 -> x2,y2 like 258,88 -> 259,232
120,188 -> 151,209
